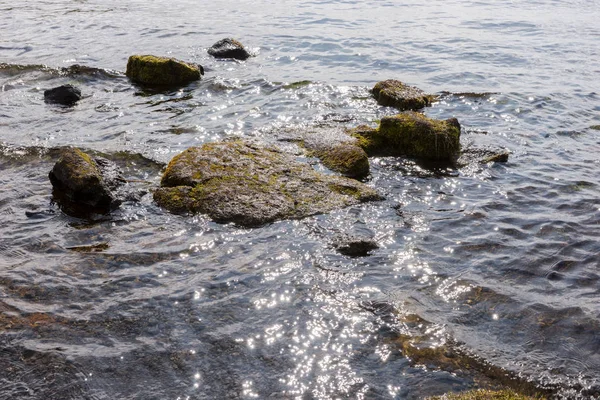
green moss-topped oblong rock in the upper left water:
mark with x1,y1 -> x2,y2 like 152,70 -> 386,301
125,55 -> 202,86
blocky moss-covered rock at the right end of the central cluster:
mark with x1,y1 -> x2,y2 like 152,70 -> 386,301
350,111 -> 460,162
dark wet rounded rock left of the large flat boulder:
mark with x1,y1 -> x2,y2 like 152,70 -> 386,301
49,148 -> 122,217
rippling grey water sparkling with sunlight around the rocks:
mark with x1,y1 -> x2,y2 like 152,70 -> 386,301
0,0 -> 600,399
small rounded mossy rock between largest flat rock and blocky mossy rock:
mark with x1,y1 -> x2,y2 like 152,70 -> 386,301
312,142 -> 369,179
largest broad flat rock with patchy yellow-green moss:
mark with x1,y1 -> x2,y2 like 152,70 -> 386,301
154,140 -> 380,226
